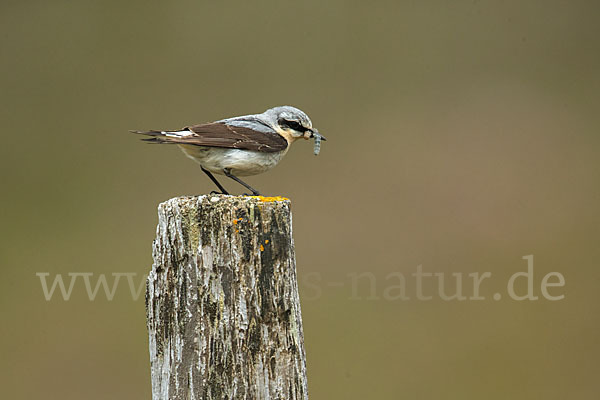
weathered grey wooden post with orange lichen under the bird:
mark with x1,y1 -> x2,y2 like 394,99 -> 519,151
146,195 -> 308,400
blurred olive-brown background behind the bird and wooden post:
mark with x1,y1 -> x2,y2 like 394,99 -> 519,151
0,0 -> 600,399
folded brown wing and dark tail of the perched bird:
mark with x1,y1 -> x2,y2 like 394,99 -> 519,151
134,122 -> 288,153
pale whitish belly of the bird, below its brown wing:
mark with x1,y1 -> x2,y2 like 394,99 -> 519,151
179,145 -> 289,176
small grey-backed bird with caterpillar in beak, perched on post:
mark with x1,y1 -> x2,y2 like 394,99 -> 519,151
131,106 -> 327,196
